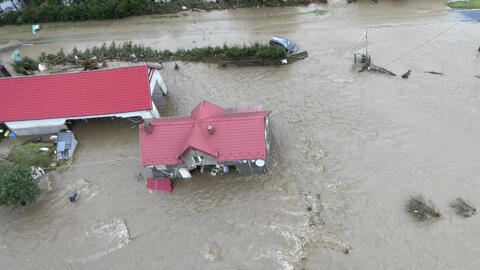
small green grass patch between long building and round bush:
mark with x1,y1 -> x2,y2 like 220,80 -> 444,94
8,143 -> 54,168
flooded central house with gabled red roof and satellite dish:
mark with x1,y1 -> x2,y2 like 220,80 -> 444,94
139,100 -> 271,179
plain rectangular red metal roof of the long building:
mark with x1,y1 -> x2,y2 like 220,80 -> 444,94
0,65 -> 154,122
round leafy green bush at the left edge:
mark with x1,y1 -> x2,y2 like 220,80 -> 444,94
0,163 -> 40,205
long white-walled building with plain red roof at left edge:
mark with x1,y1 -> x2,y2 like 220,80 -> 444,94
0,65 -> 167,135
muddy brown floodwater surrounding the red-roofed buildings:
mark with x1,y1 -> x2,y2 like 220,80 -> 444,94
0,0 -> 480,269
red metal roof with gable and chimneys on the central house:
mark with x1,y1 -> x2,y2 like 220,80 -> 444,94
139,100 -> 270,166
